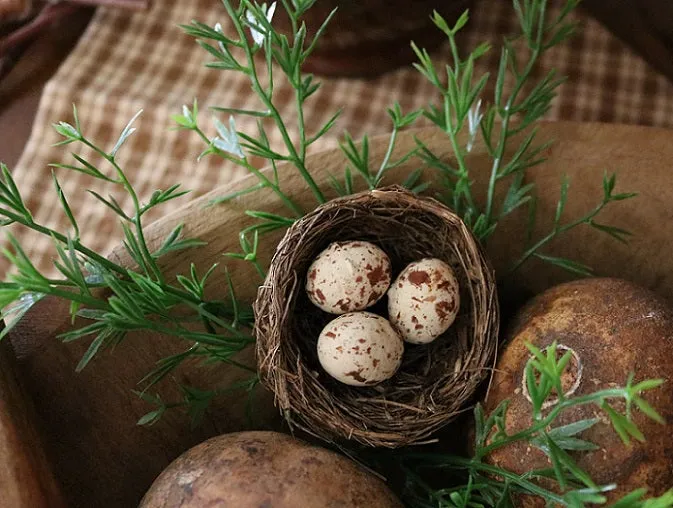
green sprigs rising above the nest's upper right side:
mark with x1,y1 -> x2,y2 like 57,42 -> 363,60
413,0 -> 635,275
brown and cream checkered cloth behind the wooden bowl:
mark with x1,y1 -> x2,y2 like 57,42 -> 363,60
5,0 -> 673,276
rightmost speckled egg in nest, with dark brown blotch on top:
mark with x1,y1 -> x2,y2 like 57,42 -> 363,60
388,258 -> 460,344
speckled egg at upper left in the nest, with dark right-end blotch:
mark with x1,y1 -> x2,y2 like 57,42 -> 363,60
306,241 -> 391,314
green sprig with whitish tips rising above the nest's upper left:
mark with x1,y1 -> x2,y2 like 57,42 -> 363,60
176,0 -> 340,211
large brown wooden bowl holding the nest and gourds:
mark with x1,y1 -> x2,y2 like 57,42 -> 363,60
0,123 -> 673,508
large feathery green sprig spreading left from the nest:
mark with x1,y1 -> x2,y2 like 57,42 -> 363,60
0,109 -> 253,387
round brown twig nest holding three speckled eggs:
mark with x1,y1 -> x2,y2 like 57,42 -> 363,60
255,188 -> 499,447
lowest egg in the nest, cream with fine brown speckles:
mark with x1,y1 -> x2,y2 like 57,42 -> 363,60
318,312 -> 404,386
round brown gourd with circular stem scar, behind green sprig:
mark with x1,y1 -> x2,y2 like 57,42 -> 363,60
485,278 -> 673,507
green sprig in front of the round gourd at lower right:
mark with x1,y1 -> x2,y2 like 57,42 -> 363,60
403,343 -> 673,508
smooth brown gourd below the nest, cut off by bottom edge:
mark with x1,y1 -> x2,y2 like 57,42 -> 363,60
139,432 -> 402,508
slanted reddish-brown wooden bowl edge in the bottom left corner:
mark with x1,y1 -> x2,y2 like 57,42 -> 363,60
0,341 -> 65,508
